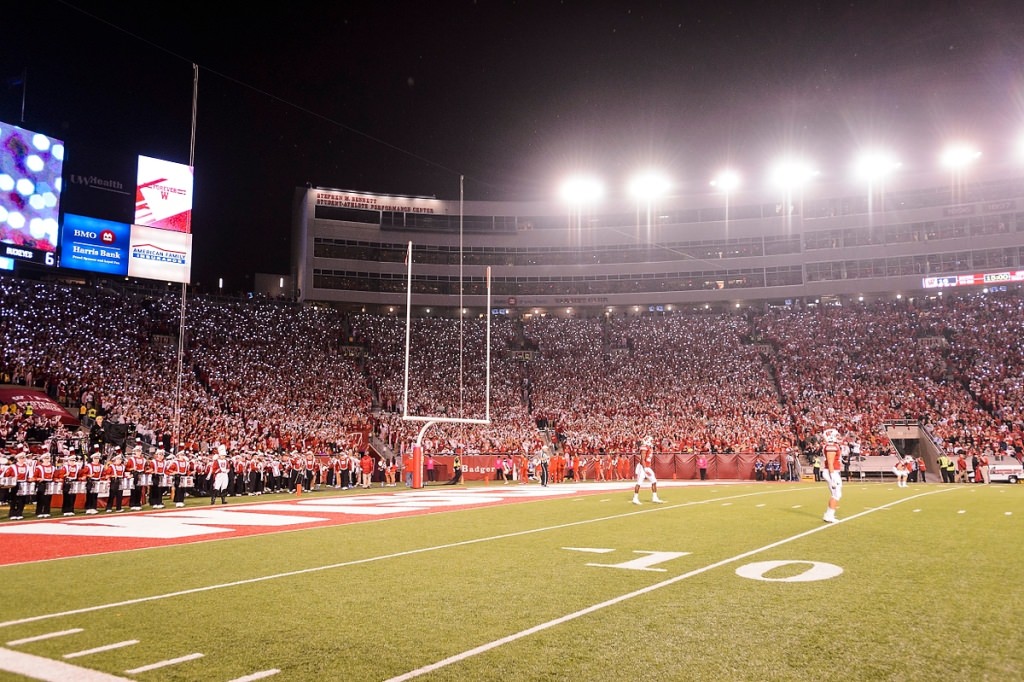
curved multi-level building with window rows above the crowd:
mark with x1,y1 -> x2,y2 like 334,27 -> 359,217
292,163 -> 1024,315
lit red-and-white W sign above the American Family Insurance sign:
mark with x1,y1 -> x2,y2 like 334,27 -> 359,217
134,156 -> 193,233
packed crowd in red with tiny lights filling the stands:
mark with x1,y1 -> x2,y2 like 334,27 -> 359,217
0,276 -> 1024,509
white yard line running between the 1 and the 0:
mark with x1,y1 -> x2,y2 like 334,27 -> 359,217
385,488 -> 955,682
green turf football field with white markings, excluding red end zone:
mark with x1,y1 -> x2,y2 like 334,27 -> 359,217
0,482 -> 1024,682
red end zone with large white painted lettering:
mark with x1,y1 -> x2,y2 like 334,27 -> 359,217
0,481 -> 647,565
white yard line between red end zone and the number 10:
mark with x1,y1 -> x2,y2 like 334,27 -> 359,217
0,487 -> 802,628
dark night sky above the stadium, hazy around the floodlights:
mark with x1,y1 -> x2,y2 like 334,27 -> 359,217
0,0 -> 1024,290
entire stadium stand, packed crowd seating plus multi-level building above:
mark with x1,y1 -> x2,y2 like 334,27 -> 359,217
0,161 -> 1024,501
